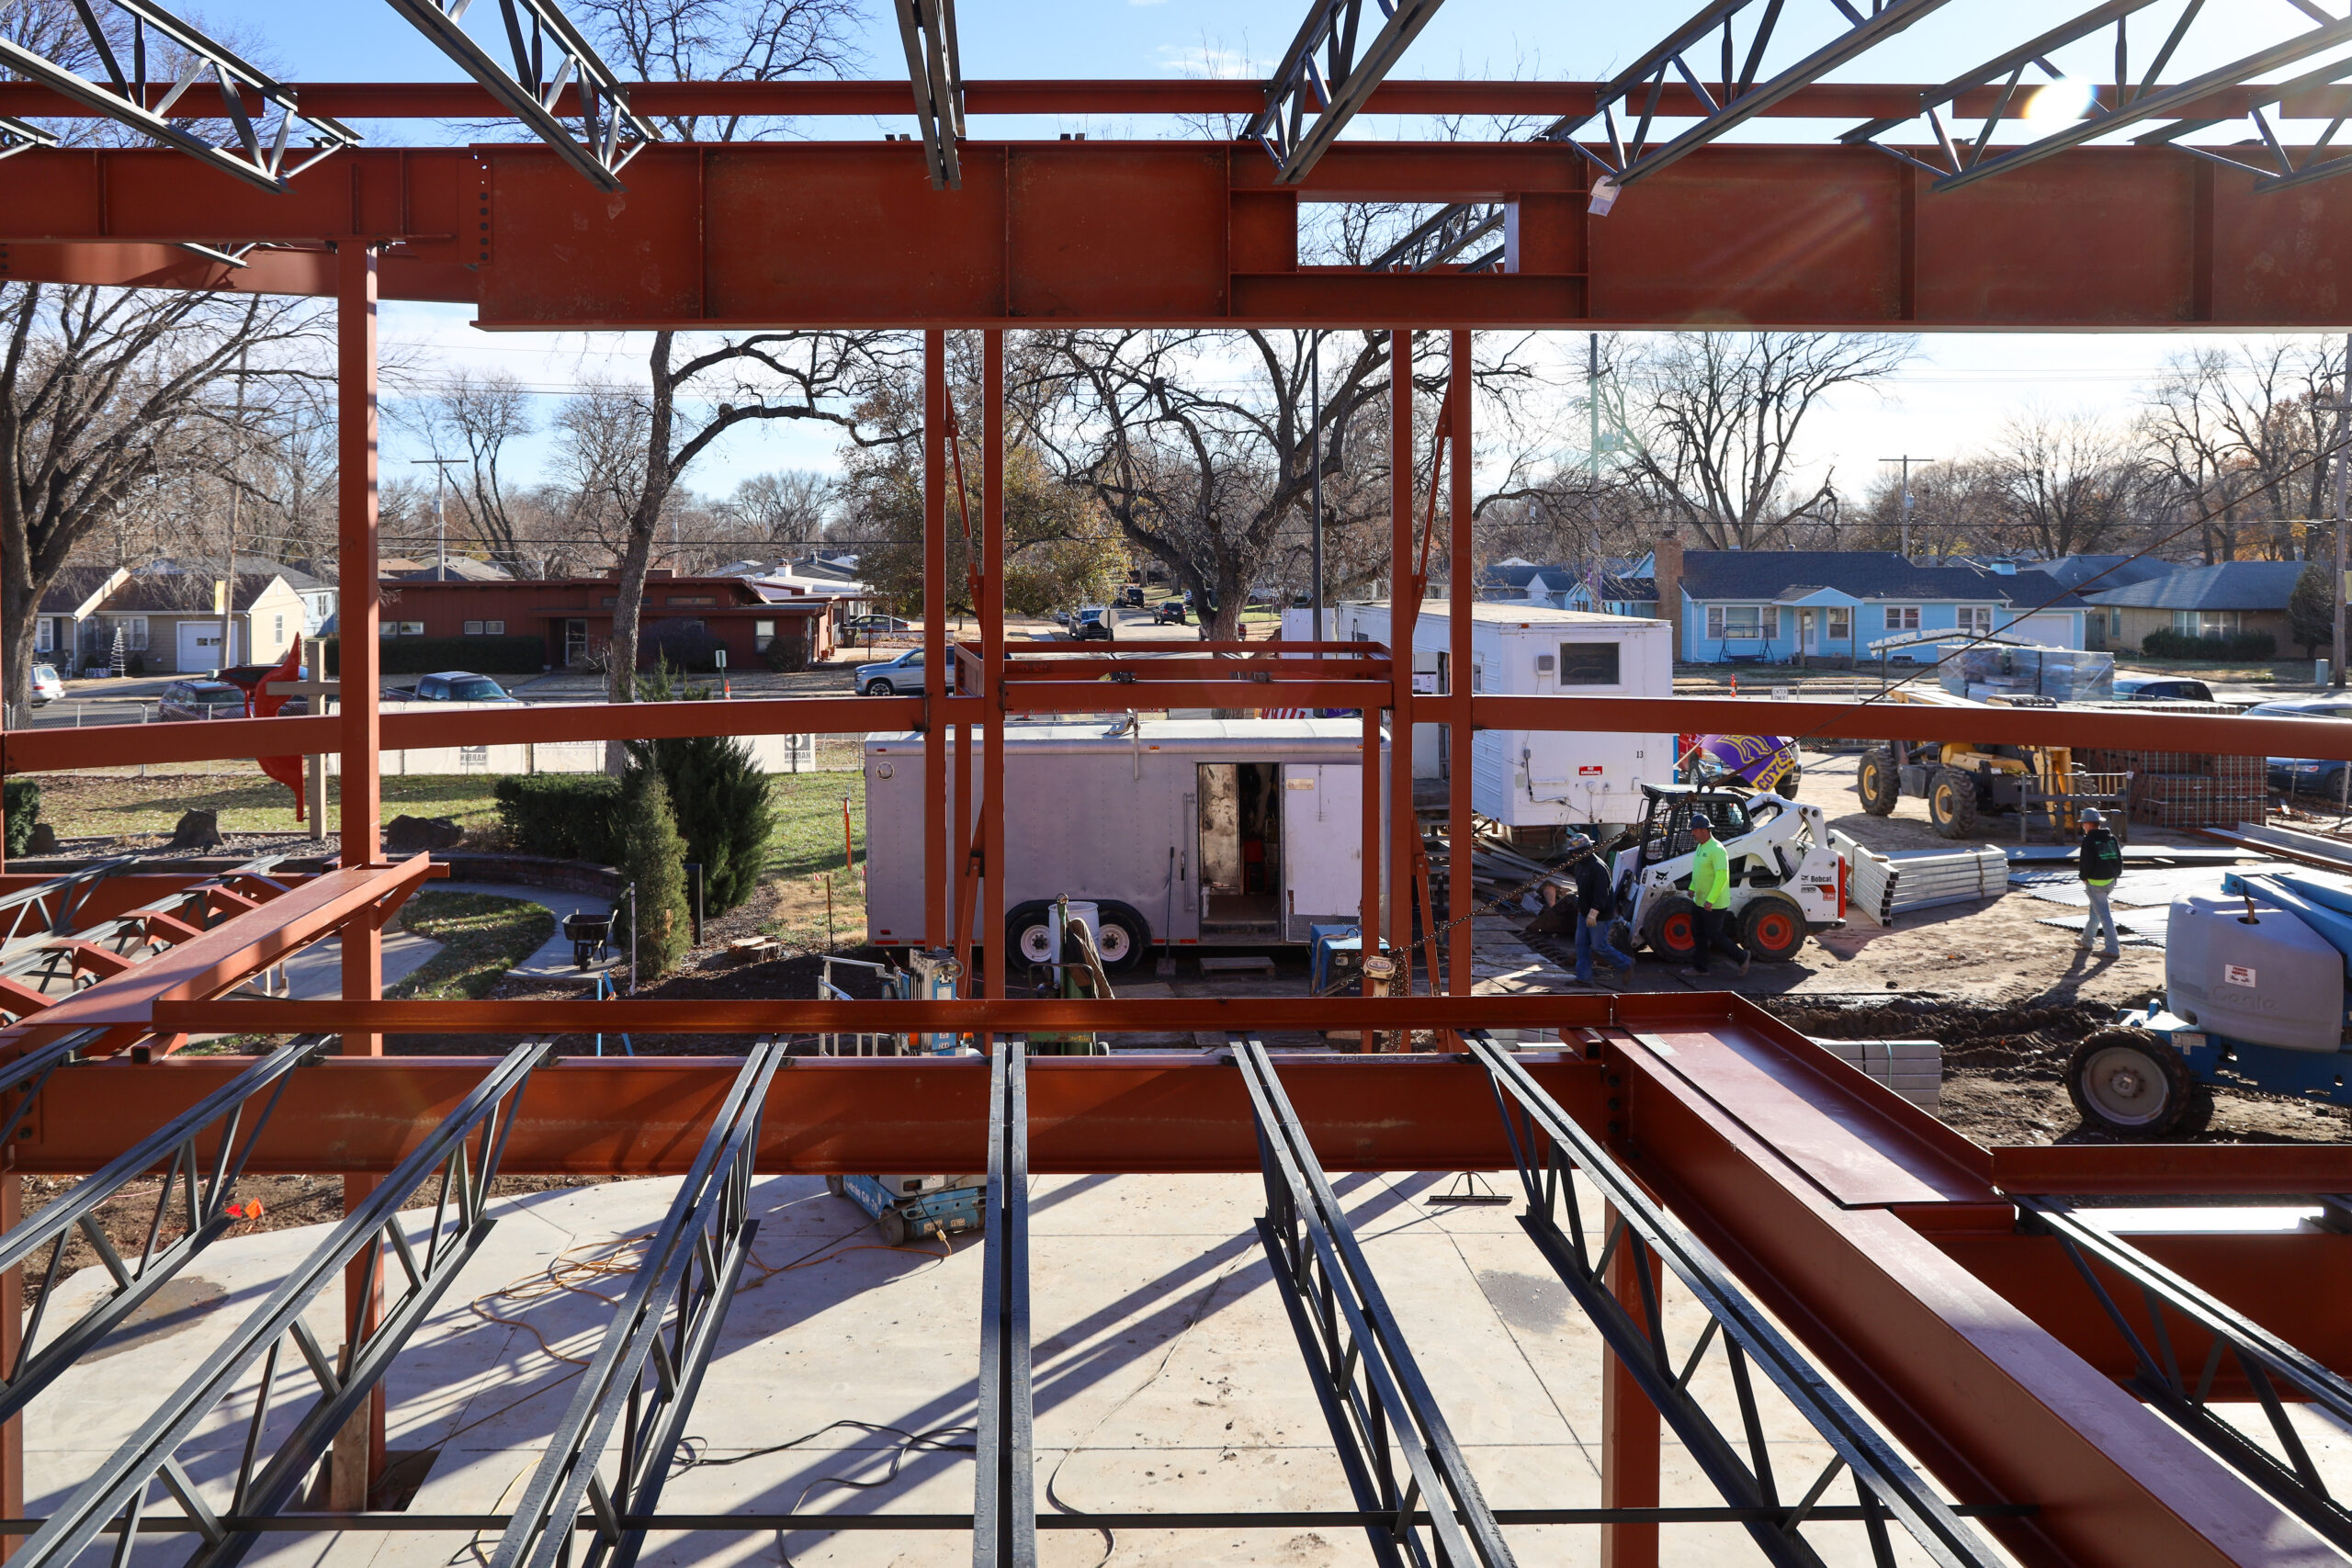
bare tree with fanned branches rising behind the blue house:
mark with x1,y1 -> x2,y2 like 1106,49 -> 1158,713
1601,332 -> 1919,550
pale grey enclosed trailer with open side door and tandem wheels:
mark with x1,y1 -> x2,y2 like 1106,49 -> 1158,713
865,717 -> 1387,971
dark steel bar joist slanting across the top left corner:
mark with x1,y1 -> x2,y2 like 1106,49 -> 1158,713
0,0 -> 360,190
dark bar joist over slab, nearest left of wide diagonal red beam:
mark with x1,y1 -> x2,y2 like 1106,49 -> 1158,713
1463,1032 -> 2007,1568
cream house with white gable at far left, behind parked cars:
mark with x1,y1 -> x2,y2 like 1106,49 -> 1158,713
96,555 -> 312,674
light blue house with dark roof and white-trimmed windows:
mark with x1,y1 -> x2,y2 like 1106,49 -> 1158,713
1634,543 -> 2086,665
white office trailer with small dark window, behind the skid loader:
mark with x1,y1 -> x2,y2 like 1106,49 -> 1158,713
1282,600 -> 1675,828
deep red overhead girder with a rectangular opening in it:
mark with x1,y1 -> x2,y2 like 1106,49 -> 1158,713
0,141 -> 2352,332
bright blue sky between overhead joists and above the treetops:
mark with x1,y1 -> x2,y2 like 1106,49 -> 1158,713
174,0 -> 2352,502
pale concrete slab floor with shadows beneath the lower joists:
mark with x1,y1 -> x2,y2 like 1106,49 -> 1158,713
26,1176 -> 2352,1568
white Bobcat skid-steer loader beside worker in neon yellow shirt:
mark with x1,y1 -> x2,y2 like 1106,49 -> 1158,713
1609,785 -> 1847,964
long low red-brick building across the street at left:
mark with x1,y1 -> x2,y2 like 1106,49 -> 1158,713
383,569 -> 847,670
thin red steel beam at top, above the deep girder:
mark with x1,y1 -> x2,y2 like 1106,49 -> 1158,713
0,77 -> 2352,120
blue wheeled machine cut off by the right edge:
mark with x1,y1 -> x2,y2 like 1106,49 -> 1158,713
2065,872 -> 2352,1138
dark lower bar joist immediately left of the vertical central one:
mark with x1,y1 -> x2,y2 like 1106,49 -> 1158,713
489,1042 -> 783,1568
